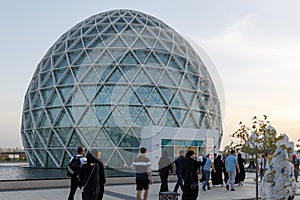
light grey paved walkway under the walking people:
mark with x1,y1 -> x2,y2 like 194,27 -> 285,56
0,177 -> 300,200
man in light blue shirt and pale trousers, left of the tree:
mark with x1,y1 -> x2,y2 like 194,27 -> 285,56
225,150 -> 240,191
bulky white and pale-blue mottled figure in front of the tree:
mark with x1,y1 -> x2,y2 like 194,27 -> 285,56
260,147 -> 297,200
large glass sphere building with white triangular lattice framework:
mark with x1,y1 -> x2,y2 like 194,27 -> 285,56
21,10 -> 222,168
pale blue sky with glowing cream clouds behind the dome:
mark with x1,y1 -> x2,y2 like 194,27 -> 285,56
0,0 -> 300,148
